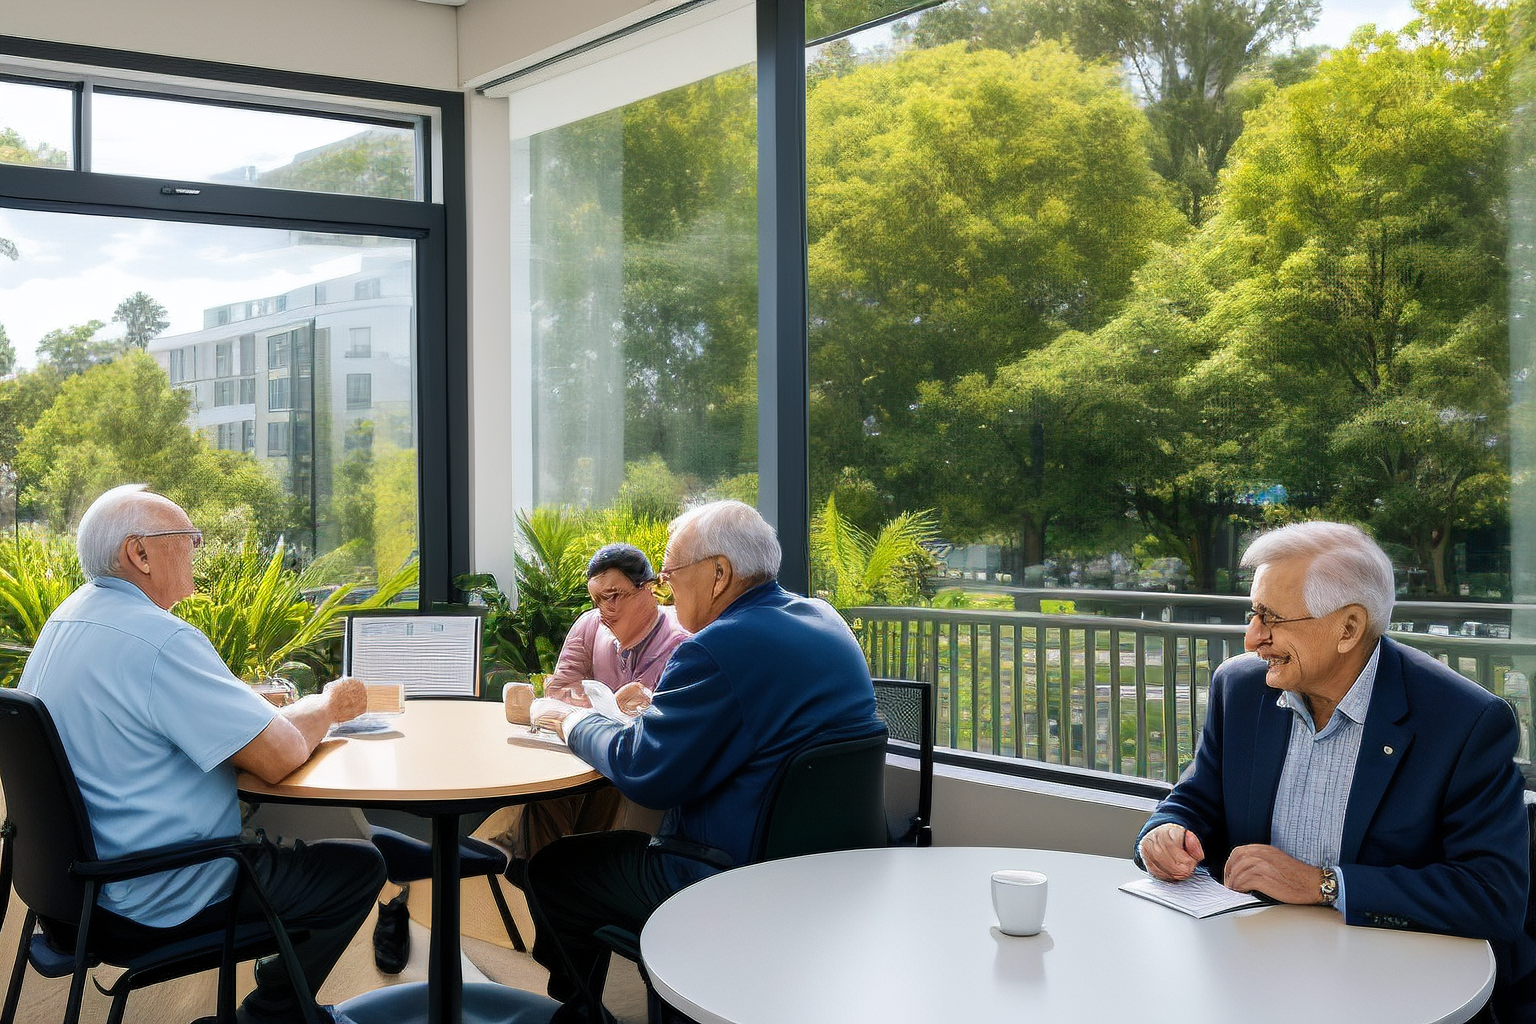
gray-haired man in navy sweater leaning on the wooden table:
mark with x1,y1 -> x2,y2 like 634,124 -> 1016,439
528,502 -> 882,1021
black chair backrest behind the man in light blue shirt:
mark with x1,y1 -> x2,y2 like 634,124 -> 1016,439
0,689 -> 97,923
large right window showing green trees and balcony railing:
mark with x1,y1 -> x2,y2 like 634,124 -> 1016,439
806,0 -> 1536,778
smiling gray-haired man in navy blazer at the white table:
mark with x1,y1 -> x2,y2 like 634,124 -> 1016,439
1137,522 -> 1536,1024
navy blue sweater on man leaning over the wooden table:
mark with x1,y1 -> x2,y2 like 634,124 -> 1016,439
570,582 -> 880,886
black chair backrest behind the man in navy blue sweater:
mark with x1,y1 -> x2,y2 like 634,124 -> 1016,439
753,729 -> 886,861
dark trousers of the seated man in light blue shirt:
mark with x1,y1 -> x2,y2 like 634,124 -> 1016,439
45,838 -> 384,1024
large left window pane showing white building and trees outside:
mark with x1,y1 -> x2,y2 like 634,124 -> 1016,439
0,210 -> 418,586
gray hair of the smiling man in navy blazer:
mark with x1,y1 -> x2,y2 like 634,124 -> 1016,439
1243,522 -> 1396,639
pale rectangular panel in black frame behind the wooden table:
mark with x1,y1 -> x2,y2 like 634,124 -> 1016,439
343,608 -> 482,700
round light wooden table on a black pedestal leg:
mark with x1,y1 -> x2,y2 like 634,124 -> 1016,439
238,699 -> 602,1024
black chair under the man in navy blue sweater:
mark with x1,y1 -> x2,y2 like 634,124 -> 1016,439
594,729 -> 889,1024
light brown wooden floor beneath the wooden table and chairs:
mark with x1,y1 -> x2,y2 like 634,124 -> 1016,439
0,803 -> 645,1024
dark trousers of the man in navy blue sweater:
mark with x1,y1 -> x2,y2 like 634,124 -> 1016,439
527,832 -> 676,1021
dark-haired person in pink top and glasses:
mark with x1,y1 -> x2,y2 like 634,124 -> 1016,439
496,543 -> 691,883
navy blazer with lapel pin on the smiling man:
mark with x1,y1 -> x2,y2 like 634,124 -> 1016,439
1137,637 -> 1536,983
